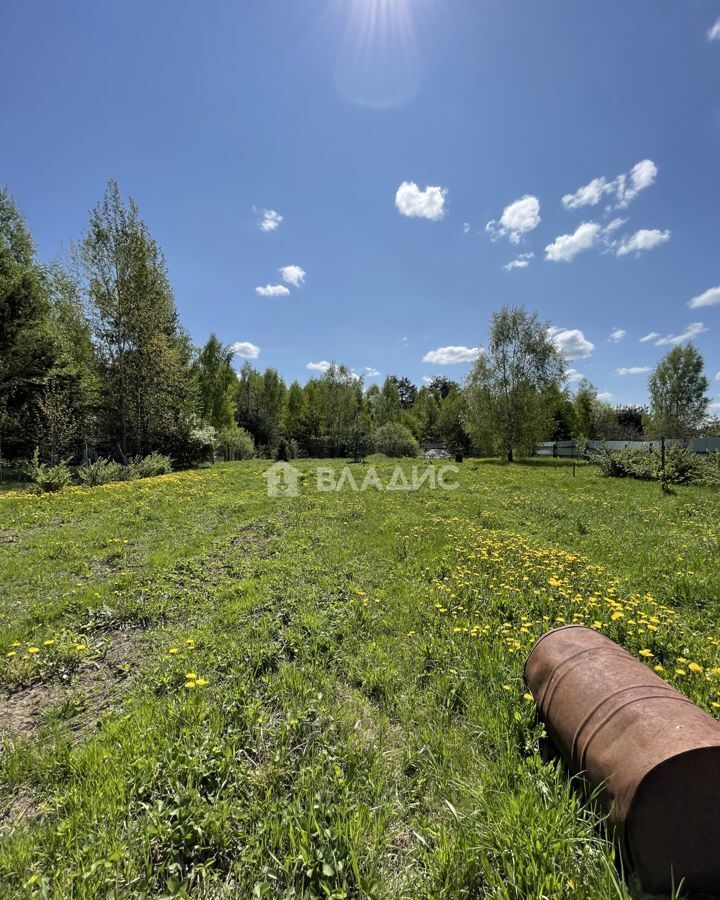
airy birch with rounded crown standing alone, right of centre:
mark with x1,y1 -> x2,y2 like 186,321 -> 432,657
466,307 -> 565,462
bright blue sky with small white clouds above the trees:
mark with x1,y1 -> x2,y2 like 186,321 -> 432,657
0,0 -> 720,402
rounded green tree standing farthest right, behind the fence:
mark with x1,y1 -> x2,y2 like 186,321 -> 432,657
648,344 -> 710,438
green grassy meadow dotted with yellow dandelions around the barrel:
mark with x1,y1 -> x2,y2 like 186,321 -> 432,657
0,460 -> 720,900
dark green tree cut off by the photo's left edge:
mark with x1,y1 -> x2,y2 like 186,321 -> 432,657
0,188 -> 55,464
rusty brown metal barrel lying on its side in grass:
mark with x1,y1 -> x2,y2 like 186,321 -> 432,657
525,625 -> 720,896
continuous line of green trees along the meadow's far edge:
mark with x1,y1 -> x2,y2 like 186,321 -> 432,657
0,181 -> 718,465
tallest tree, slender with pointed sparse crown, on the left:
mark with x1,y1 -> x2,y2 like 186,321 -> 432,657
80,181 -> 190,453
